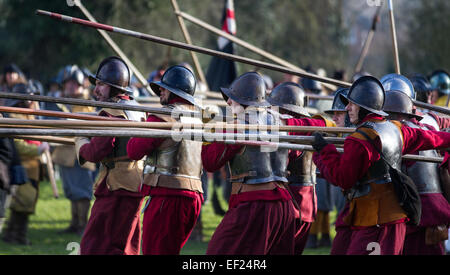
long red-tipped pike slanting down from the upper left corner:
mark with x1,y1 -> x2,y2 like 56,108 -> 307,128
36,10 -> 450,115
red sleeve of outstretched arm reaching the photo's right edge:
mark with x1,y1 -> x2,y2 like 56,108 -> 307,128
402,125 -> 450,155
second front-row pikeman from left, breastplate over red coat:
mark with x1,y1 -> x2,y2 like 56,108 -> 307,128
127,66 -> 203,255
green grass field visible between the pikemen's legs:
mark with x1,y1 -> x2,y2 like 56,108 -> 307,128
0,181 -> 335,255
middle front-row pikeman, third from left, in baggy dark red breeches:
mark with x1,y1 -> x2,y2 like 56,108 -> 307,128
202,72 -> 296,255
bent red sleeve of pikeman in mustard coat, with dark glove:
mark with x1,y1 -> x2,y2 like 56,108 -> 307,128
313,137 -> 372,189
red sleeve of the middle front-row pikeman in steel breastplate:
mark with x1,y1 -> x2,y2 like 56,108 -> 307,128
202,142 -> 242,172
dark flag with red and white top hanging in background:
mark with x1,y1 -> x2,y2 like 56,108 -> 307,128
206,0 -> 237,91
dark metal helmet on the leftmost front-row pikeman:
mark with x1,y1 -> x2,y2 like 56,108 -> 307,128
89,56 -> 132,95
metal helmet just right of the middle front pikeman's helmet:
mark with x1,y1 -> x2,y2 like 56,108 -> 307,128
266,82 -> 310,117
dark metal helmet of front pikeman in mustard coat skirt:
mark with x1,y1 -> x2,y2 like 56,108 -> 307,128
339,76 -> 388,116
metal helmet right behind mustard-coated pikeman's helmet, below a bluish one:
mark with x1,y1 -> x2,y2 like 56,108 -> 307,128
383,91 -> 423,120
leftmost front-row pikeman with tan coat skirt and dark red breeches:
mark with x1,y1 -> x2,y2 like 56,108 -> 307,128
75,56 -> 145,255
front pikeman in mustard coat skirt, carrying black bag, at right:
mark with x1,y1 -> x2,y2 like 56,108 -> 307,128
313,76 -> 450,254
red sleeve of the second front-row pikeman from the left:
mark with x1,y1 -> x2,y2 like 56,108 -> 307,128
127,115 -> 164,160
